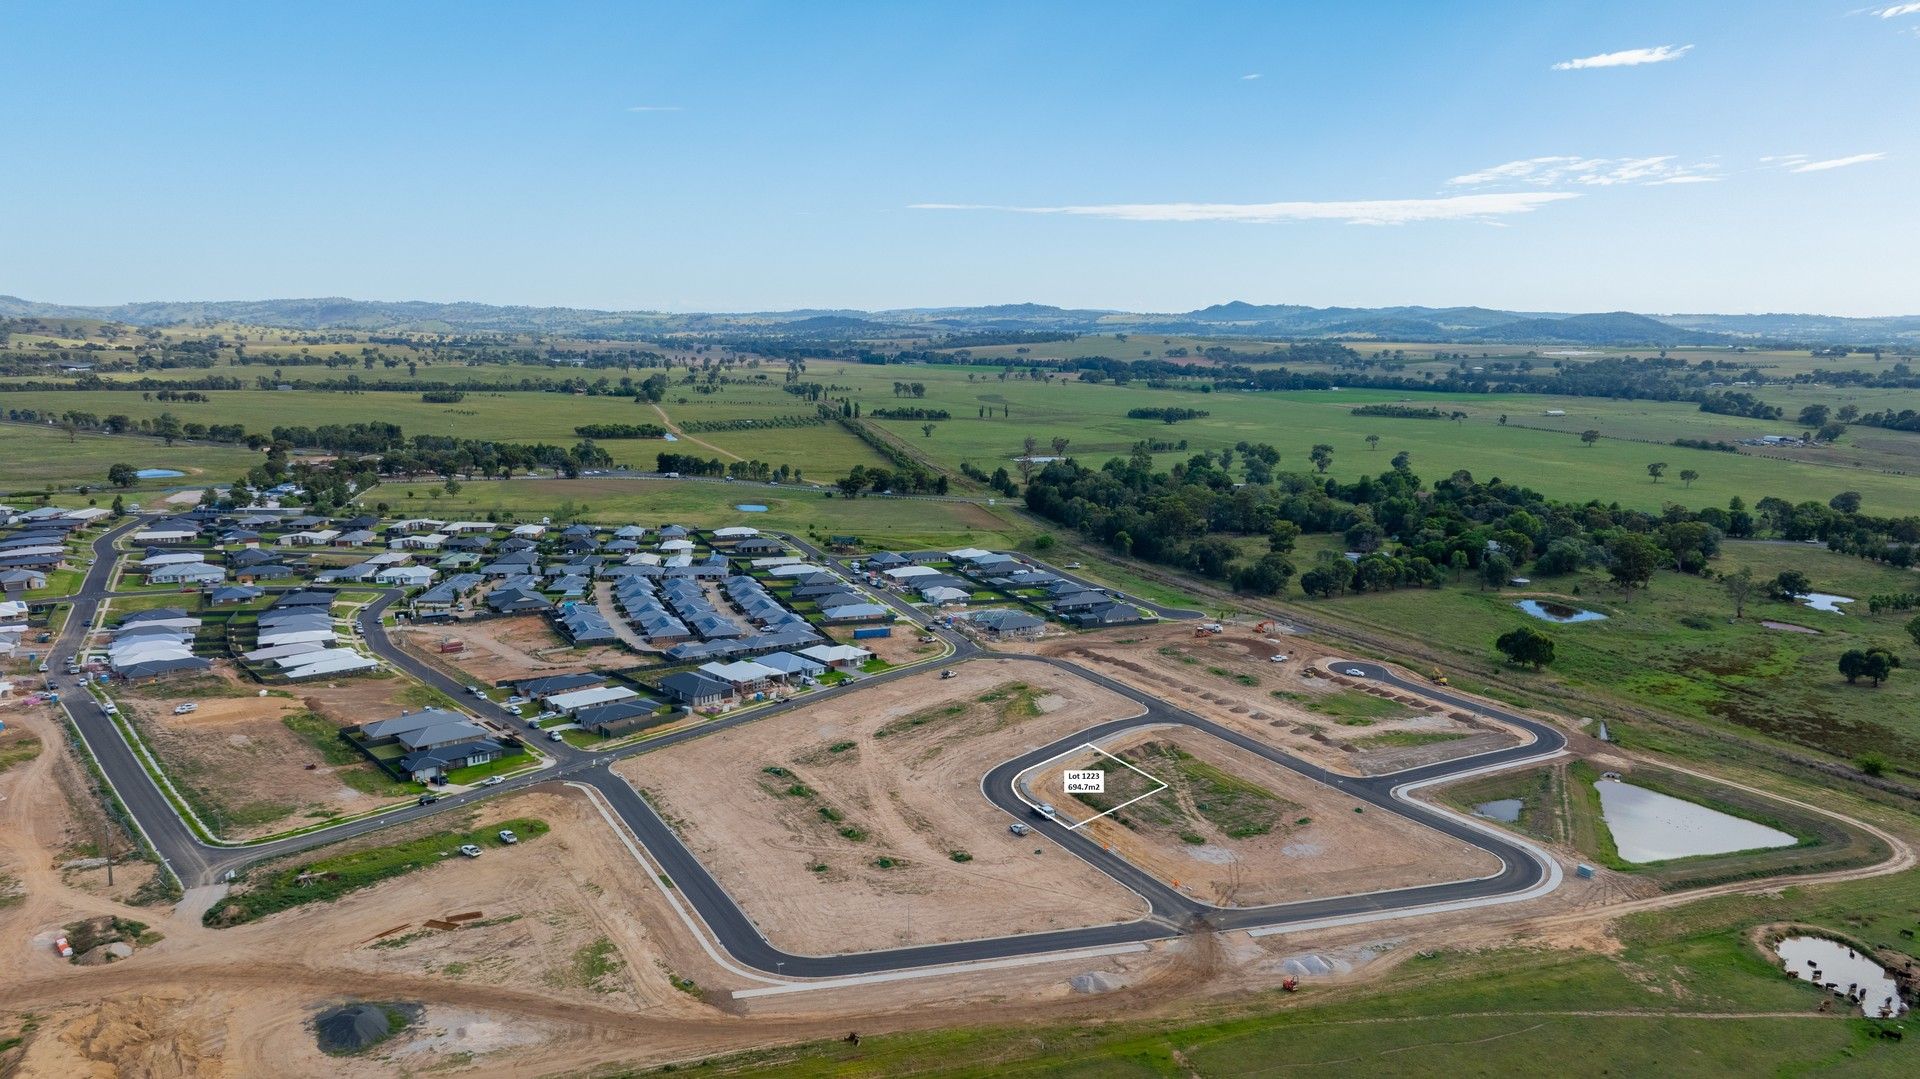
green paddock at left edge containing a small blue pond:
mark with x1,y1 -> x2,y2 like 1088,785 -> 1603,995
0,420 -> 261,487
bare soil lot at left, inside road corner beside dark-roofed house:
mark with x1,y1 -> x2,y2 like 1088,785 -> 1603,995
119,662 -> 435,839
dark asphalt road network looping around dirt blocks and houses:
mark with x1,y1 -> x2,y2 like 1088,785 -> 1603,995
50,522 -> 1565,977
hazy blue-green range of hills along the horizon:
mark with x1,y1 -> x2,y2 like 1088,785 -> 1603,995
0,296 -> 1920,348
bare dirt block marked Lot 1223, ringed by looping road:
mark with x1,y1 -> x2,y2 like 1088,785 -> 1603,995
1023,726 -> 1500,906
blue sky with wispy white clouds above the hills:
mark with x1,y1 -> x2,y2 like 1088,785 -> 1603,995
0,0 -> 1920,315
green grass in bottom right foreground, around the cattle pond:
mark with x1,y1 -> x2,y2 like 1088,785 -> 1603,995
676,872 -> 1920,1079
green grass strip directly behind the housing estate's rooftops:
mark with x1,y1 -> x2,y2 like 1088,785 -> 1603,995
361,476 -> 1031,549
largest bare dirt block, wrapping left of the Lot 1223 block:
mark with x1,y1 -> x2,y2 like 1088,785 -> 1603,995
620,660 -> 1144,954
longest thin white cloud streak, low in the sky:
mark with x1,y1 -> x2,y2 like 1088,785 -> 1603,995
908,192 -> 1580,225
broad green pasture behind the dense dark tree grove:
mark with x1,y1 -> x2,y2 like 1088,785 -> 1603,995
791,363 -> 1920,513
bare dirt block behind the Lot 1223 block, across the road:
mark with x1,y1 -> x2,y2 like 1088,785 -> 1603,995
1039,626 -> 1519,776
